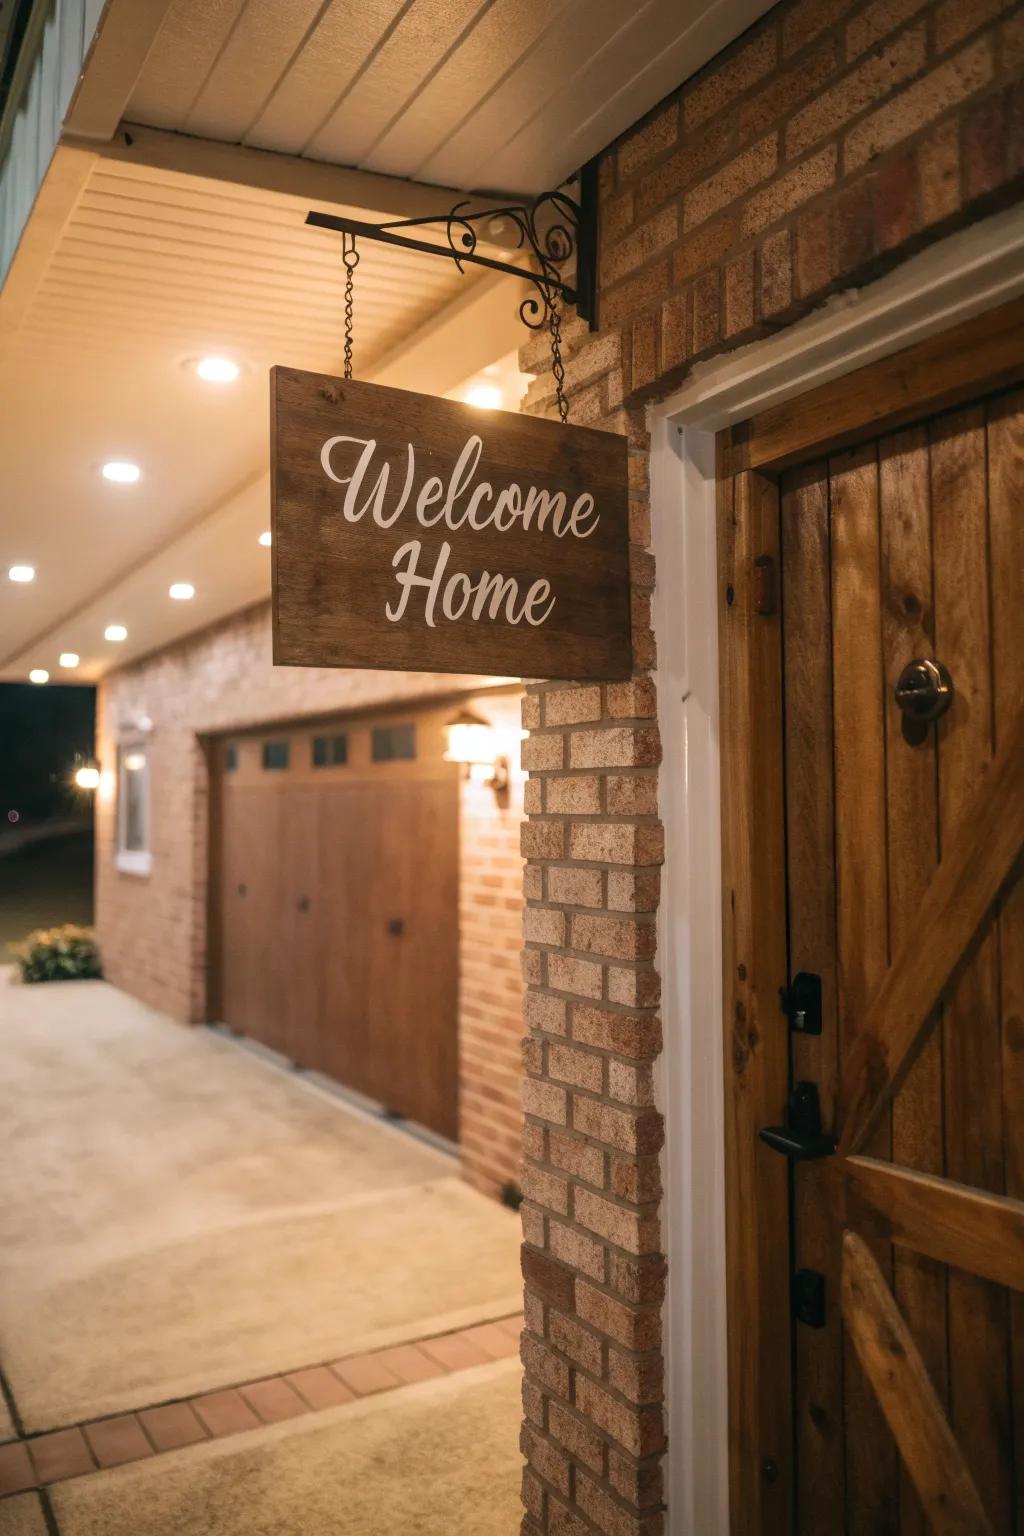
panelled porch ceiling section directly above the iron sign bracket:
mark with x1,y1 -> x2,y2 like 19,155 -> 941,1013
123,0 -> 769,194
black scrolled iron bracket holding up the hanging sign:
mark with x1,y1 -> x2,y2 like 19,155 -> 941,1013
306,164 -> 597,330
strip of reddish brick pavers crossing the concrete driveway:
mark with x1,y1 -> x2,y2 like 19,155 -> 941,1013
0,1313 -> 522,1499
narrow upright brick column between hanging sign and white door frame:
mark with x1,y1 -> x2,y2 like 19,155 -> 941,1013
522,323 -> 665,1536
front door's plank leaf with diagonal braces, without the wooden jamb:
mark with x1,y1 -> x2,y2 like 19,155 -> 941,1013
780,380 -> 1024,1536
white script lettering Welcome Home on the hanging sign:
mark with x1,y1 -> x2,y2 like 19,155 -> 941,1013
319,433 -> 600,630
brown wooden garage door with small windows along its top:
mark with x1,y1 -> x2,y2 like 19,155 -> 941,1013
215,716 -> 457,1138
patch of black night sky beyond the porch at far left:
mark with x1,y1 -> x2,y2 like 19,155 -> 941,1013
0,682 -> 95,829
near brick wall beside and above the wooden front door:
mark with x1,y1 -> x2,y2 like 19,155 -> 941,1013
522,0 -> 1024,1536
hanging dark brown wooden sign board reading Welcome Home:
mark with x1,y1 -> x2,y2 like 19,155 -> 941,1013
270,369 -> 633,679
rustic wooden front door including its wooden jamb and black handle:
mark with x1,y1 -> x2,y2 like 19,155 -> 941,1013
722,293 -> 1024,1536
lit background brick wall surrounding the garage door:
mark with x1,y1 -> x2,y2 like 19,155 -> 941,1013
95,605 -> 522,1193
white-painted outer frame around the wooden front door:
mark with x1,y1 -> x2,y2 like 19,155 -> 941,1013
649,207 -> 1024,1536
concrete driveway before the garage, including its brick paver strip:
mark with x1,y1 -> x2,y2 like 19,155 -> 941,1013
0,974 -> 520,1536
